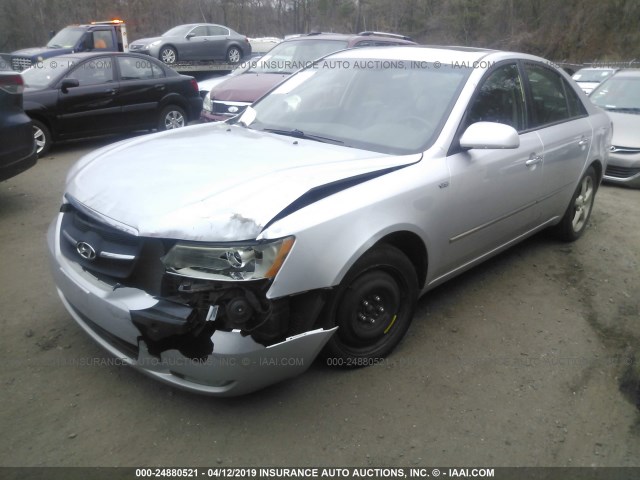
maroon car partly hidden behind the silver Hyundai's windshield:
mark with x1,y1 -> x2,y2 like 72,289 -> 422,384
200,32 -> 415,122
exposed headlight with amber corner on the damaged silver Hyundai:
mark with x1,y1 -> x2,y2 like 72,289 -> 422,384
161,237 -> 295,281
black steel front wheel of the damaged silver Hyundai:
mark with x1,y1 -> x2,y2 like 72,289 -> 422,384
324,245 -> 418,367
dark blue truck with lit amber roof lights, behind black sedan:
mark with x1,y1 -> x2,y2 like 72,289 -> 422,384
11,20 -> 129,71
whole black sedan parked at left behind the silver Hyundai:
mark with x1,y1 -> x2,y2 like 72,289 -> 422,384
23,52 -> 202,156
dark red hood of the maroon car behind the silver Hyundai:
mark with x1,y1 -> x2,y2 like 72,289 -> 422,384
210,72 -> 291,103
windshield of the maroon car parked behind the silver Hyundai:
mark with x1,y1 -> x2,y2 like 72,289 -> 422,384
250,40 -> 347,73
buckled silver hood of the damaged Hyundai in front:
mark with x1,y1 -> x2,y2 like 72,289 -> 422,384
67,123 -> 421,241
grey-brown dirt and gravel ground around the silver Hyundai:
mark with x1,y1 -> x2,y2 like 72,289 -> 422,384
0,139 -> 640,467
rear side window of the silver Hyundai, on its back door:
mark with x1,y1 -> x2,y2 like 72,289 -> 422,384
524,63 -> 586,128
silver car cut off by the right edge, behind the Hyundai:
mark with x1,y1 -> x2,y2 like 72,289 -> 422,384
589,69 -> 640,188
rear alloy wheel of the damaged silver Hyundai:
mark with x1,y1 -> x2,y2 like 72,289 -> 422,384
556,167 -> 598,242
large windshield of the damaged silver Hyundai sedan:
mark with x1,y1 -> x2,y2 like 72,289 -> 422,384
234,58 -> 470,155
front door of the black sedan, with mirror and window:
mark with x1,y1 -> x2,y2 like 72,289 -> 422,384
56,56 -> 122,137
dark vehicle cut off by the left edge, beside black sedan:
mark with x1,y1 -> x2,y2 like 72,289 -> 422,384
0,59 -> 38,180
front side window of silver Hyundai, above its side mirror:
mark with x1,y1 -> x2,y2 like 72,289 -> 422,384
466,63 -> 526,132
